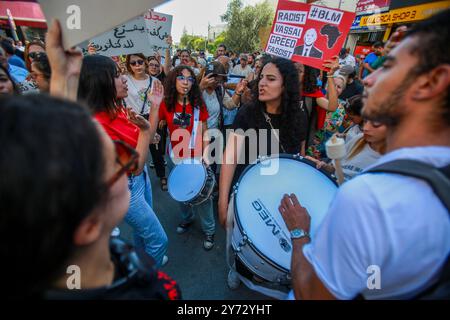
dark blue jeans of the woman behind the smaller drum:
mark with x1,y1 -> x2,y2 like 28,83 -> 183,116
180,199 -> 216,235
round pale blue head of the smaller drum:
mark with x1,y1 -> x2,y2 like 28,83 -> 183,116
168,159 -> 206,202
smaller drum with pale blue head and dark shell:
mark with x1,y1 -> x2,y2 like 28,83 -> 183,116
168,159 -> 216,206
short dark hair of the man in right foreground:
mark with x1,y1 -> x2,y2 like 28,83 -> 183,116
406,9 -> 450,125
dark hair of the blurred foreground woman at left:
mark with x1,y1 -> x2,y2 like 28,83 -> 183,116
0,95 -> 106,299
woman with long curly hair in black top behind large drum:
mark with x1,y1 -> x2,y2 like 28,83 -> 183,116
219,58 -> 307,289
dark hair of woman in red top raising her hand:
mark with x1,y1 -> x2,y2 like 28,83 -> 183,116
78,55 -> 120,118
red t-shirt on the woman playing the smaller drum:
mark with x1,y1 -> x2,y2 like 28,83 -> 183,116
159,101 -> 209,158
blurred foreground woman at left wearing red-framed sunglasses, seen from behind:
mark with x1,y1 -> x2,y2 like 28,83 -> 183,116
0,95 -> 181,300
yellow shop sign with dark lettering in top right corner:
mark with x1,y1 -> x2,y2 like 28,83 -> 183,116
359,1 -> 450,27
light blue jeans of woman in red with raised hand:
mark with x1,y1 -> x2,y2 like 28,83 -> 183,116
125,167 -> 168,267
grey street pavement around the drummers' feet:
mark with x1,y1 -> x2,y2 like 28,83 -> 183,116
120,161 -> 271,300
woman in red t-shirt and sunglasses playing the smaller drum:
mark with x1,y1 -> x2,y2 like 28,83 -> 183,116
159,65 -> 216,250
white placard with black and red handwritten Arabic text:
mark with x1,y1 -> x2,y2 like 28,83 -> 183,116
82,11 -> 173,57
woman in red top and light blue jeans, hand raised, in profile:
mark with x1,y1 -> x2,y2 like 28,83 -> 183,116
78,55 -> 168,266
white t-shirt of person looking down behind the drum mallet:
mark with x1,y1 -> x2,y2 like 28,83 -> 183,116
341,134 -> 381,181
